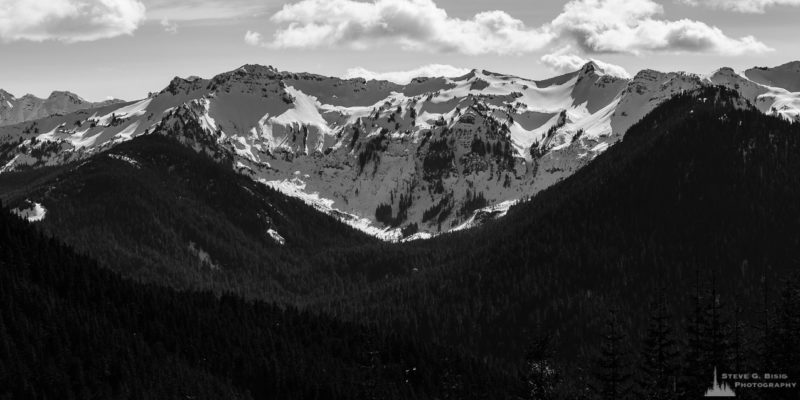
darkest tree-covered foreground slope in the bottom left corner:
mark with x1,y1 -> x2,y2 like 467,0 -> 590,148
0,203 -> 520,399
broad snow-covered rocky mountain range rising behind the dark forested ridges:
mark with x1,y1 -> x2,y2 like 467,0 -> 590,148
0,62 -> 800,239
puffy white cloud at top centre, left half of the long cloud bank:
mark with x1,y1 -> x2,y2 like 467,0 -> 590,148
270,0 -> 551,55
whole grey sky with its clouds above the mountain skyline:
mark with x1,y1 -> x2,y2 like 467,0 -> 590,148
0,0 -> 800,101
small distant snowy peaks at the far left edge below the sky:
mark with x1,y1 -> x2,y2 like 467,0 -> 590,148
0,89 -> 123,126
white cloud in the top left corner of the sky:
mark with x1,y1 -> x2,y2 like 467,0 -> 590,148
0,0 -> 145,43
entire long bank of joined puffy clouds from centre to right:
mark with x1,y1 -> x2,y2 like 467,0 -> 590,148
265,0 -> 776,55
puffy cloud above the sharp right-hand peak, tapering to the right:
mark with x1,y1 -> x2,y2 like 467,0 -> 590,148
550,0 -> 771,55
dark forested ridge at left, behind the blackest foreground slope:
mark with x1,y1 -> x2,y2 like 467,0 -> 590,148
0,134 -> 410,303
